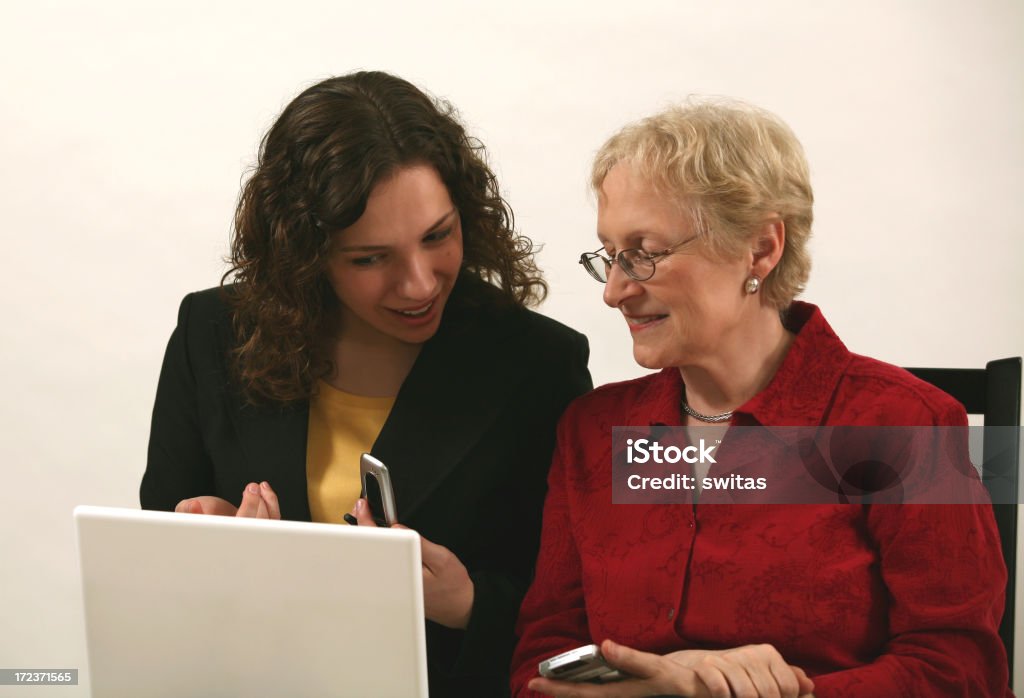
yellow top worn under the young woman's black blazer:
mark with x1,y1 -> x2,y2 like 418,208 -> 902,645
306,381 -> 394,523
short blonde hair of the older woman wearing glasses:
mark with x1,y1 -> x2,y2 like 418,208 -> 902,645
591,99 -> 814,309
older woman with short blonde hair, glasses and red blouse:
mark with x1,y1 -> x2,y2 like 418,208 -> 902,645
512,101 -> 1009,698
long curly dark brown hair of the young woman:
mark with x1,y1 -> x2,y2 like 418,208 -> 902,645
221,72 -> 547,403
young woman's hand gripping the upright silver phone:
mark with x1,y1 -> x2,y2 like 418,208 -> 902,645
352,498 -> 474,629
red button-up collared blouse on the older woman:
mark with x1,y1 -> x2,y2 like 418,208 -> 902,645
512,303 -> 1013,698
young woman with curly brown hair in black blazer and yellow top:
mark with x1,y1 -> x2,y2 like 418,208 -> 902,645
141,73 -> 591,695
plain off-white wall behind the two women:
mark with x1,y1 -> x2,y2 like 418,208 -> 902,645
0,0 -> 1024,696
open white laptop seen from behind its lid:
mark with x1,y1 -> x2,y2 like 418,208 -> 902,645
75,507 -> 427,698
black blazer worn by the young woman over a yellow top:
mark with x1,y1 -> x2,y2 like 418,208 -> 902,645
140,279 -> 592,696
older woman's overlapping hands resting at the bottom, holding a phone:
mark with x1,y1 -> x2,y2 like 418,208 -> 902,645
528,640 -> 814,698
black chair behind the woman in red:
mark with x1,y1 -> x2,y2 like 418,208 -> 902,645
907,356 -> 1021,686
